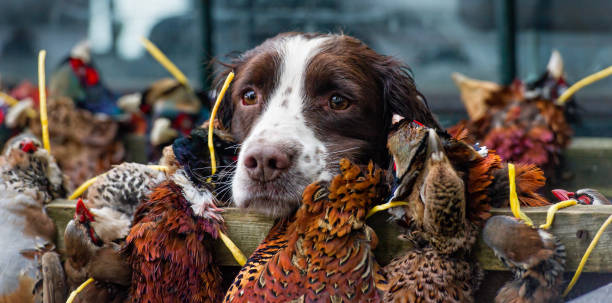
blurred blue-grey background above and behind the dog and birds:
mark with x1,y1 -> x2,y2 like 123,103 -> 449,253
0,0 -> 612,136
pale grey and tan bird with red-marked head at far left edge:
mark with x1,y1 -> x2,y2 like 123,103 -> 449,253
0,135 -> 69,302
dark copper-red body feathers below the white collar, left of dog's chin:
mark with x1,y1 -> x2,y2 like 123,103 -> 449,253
124,181 -> 222,302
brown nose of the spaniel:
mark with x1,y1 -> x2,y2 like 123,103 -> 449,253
244,145 -> 291,182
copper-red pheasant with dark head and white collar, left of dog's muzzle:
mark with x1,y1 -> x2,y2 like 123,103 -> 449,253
119,120 -> 237,302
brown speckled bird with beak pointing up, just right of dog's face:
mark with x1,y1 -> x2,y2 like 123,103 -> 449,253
384,125 -> 482,302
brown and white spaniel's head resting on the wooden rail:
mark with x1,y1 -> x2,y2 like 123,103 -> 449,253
219,33 -> 438,217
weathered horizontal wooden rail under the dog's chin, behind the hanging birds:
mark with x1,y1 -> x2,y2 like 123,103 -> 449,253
47,200 -> 612,272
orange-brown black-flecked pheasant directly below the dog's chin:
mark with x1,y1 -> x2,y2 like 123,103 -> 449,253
225,160 -> 386,302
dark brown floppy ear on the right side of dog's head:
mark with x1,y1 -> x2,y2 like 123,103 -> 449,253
381,57 -> 442,129
